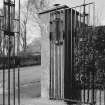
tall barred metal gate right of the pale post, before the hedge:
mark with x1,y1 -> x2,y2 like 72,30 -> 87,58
50,3 -> 97,104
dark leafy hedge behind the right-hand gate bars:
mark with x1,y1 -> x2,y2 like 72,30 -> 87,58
74,26 -> 105,87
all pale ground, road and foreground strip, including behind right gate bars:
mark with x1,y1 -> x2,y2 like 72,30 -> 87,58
0,66 -> 105,105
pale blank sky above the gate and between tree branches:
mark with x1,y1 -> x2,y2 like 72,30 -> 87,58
0,0 -> 105,42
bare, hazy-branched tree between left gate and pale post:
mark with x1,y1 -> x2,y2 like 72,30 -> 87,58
21,0 -> 48,49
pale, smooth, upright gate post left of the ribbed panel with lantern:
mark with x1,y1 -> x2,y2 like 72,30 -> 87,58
40,14 -> 50,99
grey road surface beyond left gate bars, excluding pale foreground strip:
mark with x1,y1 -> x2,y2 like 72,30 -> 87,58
0,66 -> 41,104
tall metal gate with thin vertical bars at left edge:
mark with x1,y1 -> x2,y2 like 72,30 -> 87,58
0,0 -> 20,105
